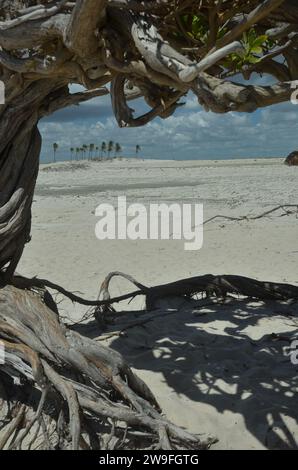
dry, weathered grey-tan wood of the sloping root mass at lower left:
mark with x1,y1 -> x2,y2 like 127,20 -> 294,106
0,280 -> 213,449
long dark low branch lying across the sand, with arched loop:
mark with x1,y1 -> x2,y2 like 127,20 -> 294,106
4,268 -> 298,320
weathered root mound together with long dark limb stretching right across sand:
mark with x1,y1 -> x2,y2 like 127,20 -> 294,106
0,272 -> 298,449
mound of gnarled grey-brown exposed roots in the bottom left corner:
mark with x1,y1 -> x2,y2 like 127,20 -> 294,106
0,285 -> 212,449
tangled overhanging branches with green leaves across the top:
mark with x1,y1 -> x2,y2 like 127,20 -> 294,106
0,0 -> 298,126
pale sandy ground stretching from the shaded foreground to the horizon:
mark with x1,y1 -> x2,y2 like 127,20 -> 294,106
19,159 -> 298,449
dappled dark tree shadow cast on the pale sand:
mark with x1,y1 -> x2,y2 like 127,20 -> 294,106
90,299 -> 298,449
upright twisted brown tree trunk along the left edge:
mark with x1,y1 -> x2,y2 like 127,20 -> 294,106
0,76 -> 57,279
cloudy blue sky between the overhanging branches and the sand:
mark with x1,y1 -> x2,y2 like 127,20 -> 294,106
39,80 -> 298,162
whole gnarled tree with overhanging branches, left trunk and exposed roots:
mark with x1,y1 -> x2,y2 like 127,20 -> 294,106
0,0 -> 298,448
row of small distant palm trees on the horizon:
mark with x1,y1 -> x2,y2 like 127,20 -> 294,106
53,140 -> 141,162
